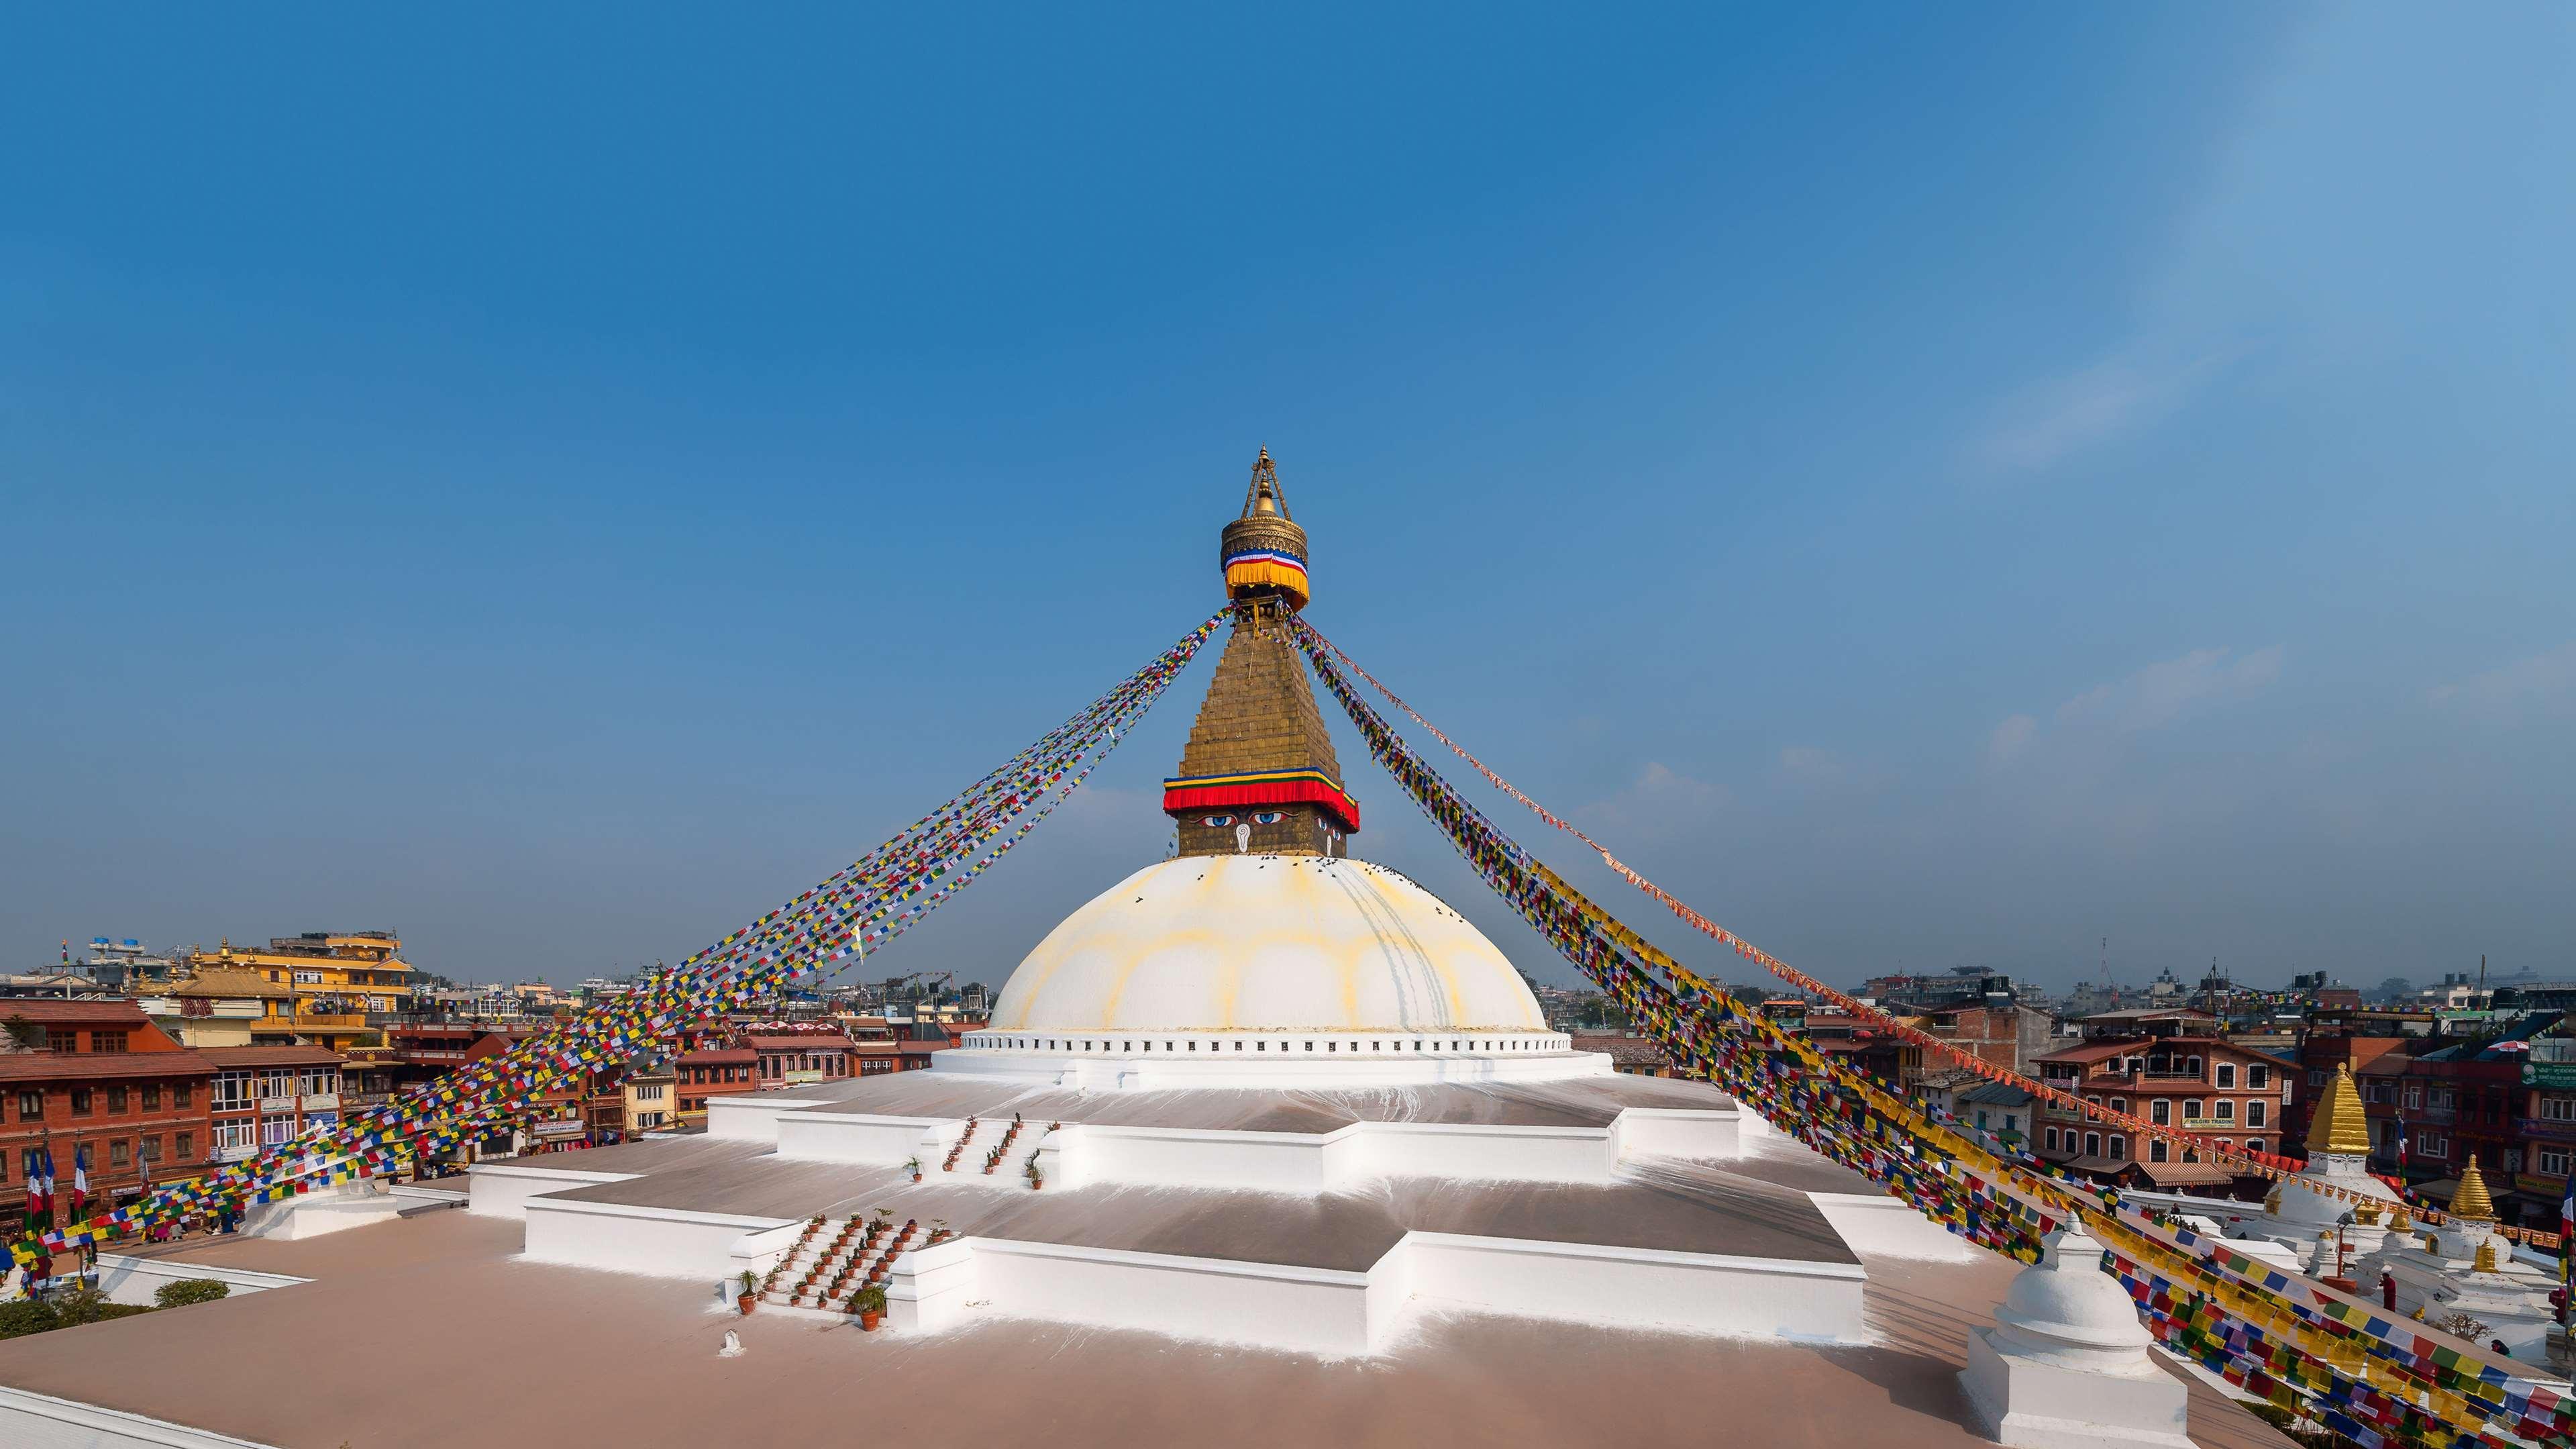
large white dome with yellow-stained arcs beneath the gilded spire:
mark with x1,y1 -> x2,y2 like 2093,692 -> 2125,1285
989,854 -> 1548,1034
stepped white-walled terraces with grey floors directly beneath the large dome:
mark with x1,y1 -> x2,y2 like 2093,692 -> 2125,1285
472,1070 -> 1965,1354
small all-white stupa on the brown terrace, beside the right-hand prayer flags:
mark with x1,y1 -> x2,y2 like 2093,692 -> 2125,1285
1960,1228 -> 2192,1449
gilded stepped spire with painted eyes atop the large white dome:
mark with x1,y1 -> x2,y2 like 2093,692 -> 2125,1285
1162,448 -> 1360,856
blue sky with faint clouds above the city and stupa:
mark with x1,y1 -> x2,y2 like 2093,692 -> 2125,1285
0,5 -> 2576,985
